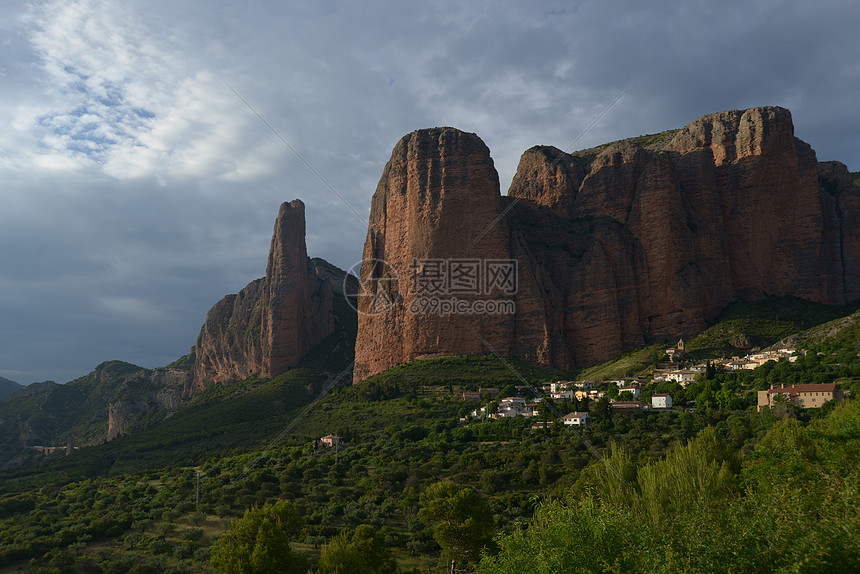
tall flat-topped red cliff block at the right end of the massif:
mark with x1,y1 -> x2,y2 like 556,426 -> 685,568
669,107 -> 828,302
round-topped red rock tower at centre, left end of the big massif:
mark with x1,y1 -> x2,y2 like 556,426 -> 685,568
354,128 -> 514,380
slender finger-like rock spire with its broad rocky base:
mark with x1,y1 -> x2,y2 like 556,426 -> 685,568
194,200 -> 334,388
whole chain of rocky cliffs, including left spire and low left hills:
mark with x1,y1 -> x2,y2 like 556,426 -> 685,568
0,103 -> 860,472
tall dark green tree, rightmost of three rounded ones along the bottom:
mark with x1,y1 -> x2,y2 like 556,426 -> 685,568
418,482 -> 494,573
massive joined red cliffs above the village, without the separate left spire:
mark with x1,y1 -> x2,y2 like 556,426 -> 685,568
355,107 -> 860,380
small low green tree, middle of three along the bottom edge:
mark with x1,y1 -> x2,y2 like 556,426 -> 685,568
318,524 -> 397,574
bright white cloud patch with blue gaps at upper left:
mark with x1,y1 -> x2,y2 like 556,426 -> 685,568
15,0 -> 274,181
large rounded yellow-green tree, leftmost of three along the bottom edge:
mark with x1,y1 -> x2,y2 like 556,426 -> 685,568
210,500 -> 308,574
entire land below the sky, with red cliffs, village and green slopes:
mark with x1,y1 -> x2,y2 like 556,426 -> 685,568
0,107 -> 860,573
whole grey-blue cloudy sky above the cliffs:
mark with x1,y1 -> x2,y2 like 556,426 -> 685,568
0,0 -> 860,383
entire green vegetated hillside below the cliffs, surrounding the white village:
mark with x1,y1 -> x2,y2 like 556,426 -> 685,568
0,300 -> 860,572
